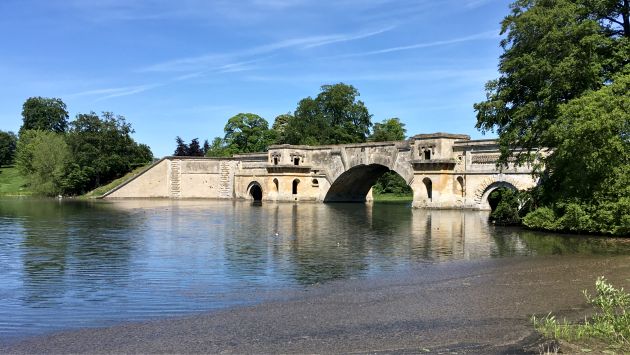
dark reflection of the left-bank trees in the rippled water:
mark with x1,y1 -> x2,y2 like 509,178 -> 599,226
0,200 -> 141,303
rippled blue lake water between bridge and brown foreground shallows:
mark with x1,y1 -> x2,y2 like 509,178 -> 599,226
0,199 -> 630,342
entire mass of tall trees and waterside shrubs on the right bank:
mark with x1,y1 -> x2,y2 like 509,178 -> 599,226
482,0 -> 630,236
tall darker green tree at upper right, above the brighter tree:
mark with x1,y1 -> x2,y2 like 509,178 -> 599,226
474,0 -> 630,163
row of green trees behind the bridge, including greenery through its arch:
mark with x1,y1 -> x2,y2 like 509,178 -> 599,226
173,83 -> 411,195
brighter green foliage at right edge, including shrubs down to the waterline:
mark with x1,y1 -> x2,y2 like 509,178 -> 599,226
524,74 -> 630,235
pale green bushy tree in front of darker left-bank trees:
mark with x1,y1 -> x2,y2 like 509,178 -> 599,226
16,131 -> 71,196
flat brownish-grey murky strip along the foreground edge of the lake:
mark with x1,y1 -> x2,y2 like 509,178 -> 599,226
0,256 -> 630,354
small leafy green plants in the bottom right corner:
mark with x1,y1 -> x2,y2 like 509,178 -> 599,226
532,277 -> 630,351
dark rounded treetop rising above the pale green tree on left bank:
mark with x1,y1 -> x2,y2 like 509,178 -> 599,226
20,96 -> 68,134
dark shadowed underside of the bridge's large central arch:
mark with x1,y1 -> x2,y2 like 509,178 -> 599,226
324,164 -> 414,202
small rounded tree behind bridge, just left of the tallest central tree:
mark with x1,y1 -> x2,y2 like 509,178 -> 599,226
224,113 -> 274,153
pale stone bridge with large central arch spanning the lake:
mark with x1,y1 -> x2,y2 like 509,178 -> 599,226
103,133 -> 536,209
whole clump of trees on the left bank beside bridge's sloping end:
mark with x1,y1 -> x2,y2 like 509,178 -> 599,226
0,97 -> 153,195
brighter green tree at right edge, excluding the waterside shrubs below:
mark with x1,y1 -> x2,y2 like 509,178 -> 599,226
543,71 -> 630,206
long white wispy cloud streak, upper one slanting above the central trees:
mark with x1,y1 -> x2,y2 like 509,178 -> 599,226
140,26 -> 394,72
